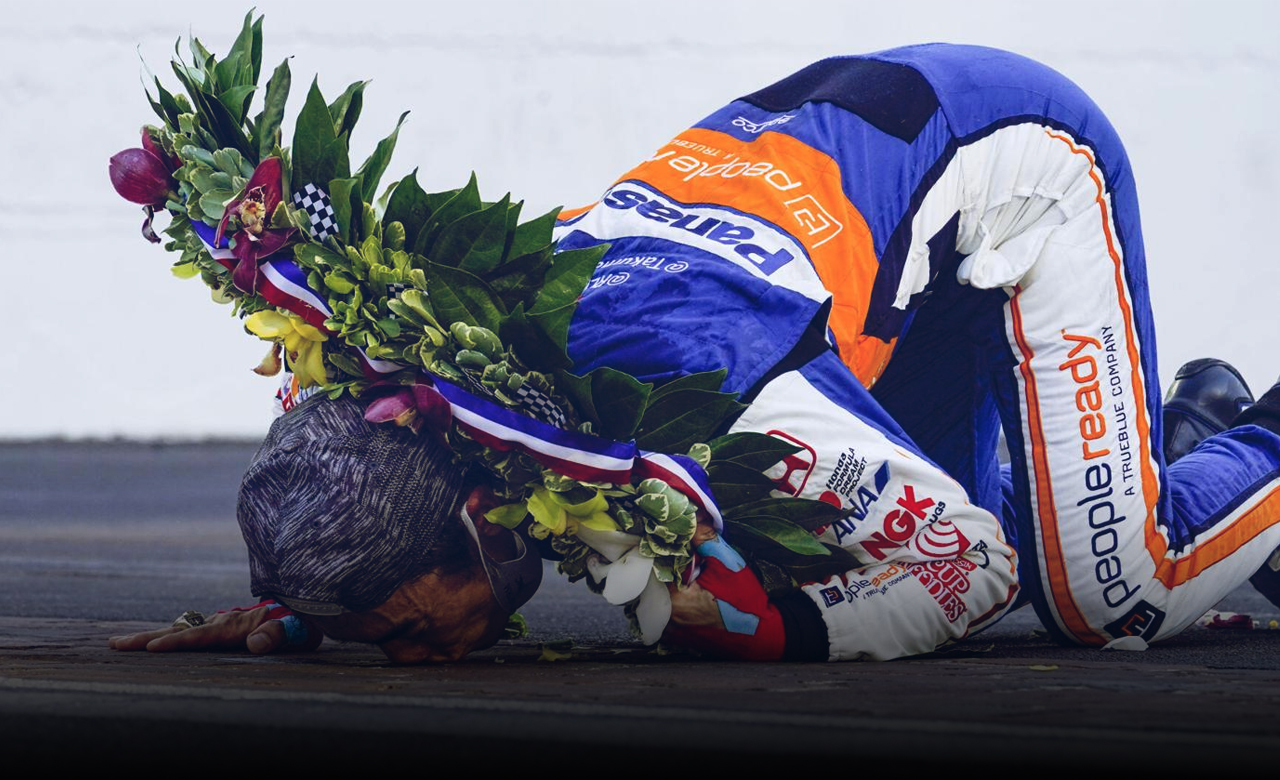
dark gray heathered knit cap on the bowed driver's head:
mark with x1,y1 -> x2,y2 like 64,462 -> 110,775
236,396 -> 470,615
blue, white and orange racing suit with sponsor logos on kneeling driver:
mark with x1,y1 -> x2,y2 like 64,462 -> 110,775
557,45 -> 1280,660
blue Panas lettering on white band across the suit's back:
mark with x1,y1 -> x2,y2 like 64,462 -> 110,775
603,184 -> 796,277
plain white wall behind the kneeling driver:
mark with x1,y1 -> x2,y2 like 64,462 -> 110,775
0,0 -> 1280,438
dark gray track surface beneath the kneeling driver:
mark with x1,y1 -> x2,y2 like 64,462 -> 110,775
0,442 -> 1280,763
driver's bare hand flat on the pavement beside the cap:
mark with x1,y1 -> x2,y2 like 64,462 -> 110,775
108,601 -> 324,654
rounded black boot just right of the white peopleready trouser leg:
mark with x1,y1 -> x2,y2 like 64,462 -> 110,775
1164,357 -> 1253,464
